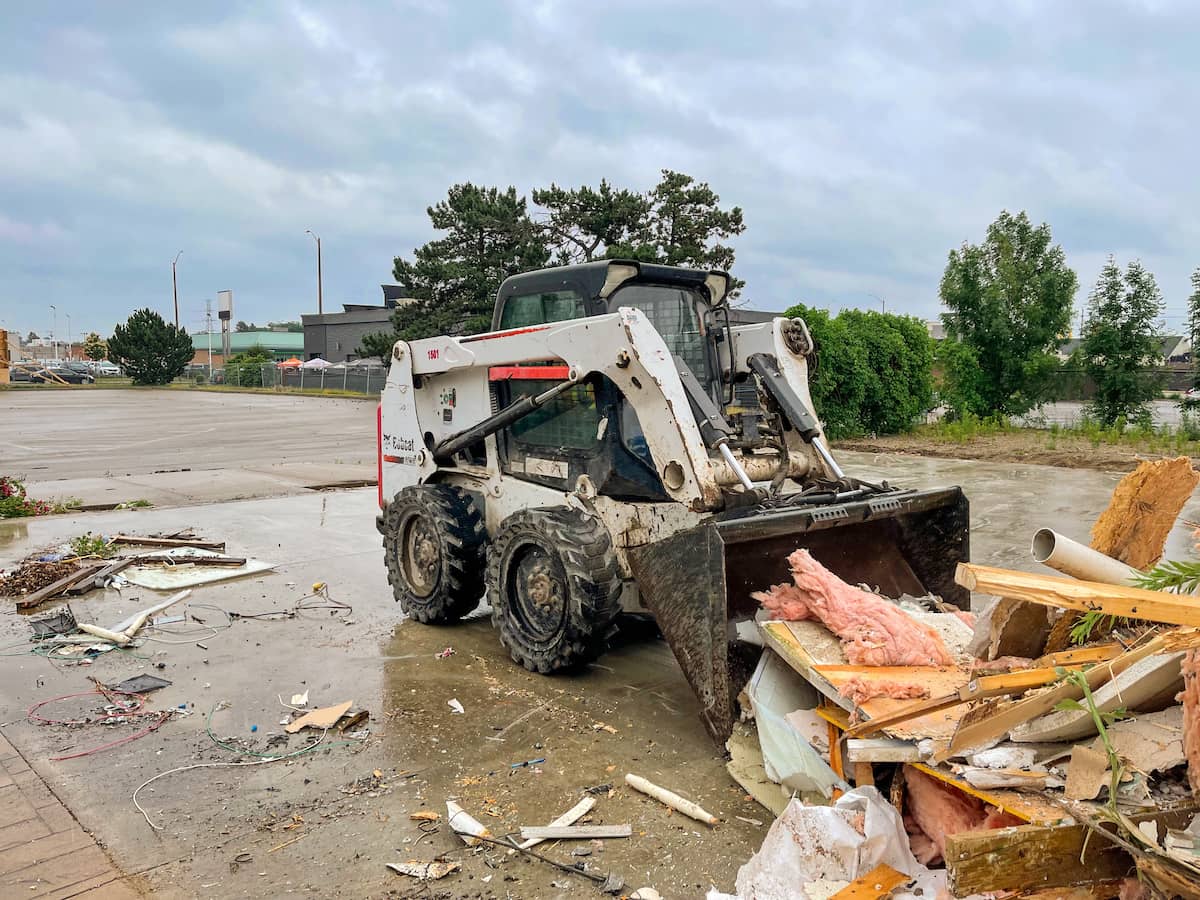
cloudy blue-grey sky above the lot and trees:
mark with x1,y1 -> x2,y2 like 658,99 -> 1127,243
0,0 -> 1200,336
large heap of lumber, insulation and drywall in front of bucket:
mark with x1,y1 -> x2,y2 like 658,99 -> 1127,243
709,458 -> 1200,900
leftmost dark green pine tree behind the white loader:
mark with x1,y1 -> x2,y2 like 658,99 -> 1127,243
359,184 -> 550,359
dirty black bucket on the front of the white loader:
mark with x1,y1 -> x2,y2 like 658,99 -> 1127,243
629,487 -> 971,744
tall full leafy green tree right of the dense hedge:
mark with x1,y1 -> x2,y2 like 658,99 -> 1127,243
940,211 -> 1078,415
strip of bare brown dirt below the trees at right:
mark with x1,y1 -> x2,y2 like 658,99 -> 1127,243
835,428 -> 1200,472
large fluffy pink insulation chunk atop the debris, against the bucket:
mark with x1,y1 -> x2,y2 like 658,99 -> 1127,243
752,550 -> 954,666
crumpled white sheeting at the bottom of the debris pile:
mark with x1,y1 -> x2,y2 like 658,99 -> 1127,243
737,787 -> 944,900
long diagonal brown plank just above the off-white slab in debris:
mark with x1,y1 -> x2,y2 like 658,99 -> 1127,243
934,629 -> 1200,762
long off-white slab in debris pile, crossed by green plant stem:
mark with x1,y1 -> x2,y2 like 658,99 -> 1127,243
1012,653 -> 1183,743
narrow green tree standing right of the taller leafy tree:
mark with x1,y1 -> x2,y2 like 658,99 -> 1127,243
1082,257 -> 1163,425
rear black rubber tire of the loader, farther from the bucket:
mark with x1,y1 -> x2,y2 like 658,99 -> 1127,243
378,485 -> 487,625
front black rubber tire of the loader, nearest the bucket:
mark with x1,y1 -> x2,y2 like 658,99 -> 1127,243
487,506 -> 622,674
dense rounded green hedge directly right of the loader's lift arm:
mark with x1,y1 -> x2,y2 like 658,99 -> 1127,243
785,305 -> 934,438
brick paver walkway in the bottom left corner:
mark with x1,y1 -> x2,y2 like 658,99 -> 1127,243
0,736 -> 142,900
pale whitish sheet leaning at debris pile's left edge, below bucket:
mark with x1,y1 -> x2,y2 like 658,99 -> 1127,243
746,650 -> 845,798
